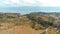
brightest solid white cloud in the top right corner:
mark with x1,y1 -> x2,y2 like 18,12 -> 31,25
37,0 -> 60,7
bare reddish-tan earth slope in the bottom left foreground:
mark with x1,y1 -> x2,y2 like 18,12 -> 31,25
0,25 -> 43,34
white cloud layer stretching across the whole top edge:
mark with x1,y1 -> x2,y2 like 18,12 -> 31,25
0,0 -> 60,7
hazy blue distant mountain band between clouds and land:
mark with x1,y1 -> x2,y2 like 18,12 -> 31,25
0,6 -> 60,13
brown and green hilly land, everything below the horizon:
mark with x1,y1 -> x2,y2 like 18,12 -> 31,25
0,12 -> 60,34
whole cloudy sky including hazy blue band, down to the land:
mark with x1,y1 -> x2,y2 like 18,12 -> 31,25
0,0 -> 60,13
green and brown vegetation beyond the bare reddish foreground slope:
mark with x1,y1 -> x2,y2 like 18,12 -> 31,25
0,13 -> 60,34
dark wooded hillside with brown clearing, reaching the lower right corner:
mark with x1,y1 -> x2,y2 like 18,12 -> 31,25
26,14 -> 60,34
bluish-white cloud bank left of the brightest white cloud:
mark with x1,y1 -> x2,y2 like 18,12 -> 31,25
0,0 -> 36,7
